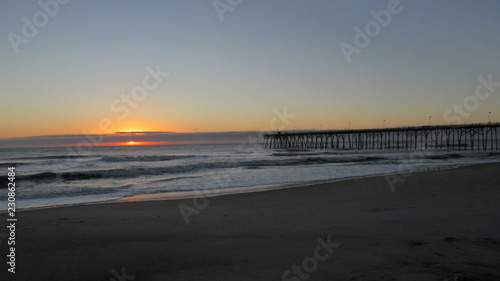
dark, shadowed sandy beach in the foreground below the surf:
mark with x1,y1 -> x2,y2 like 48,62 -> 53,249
0,164 -> 500,281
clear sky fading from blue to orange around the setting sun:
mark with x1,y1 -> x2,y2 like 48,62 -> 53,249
0,0 -> 500,146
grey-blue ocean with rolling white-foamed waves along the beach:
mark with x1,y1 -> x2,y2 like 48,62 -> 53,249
0,143 -> 500,210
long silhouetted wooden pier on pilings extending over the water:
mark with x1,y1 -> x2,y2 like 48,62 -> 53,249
263,123 -> 500,150
